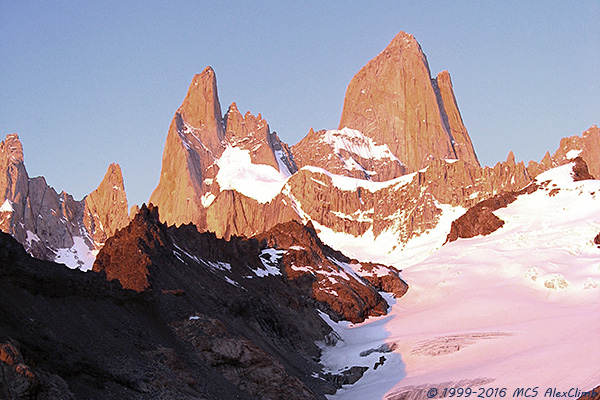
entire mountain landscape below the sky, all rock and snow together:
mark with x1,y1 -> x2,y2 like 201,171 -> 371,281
0,32 -> 600,399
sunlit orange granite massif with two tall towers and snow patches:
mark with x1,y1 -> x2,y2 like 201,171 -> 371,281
150,32 -> 600,260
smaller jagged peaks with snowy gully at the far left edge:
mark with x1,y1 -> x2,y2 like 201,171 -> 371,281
0,134 -> 128,268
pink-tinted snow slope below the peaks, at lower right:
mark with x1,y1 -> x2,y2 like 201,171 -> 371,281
322,164 -> 600,399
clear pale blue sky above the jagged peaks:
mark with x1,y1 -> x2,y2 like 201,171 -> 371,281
0,0 -> 600,205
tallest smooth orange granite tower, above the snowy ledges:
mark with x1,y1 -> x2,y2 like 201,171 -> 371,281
339,32 -> 478,172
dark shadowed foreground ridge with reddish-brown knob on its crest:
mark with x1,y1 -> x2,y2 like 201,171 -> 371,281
0,206 -> 406,399
